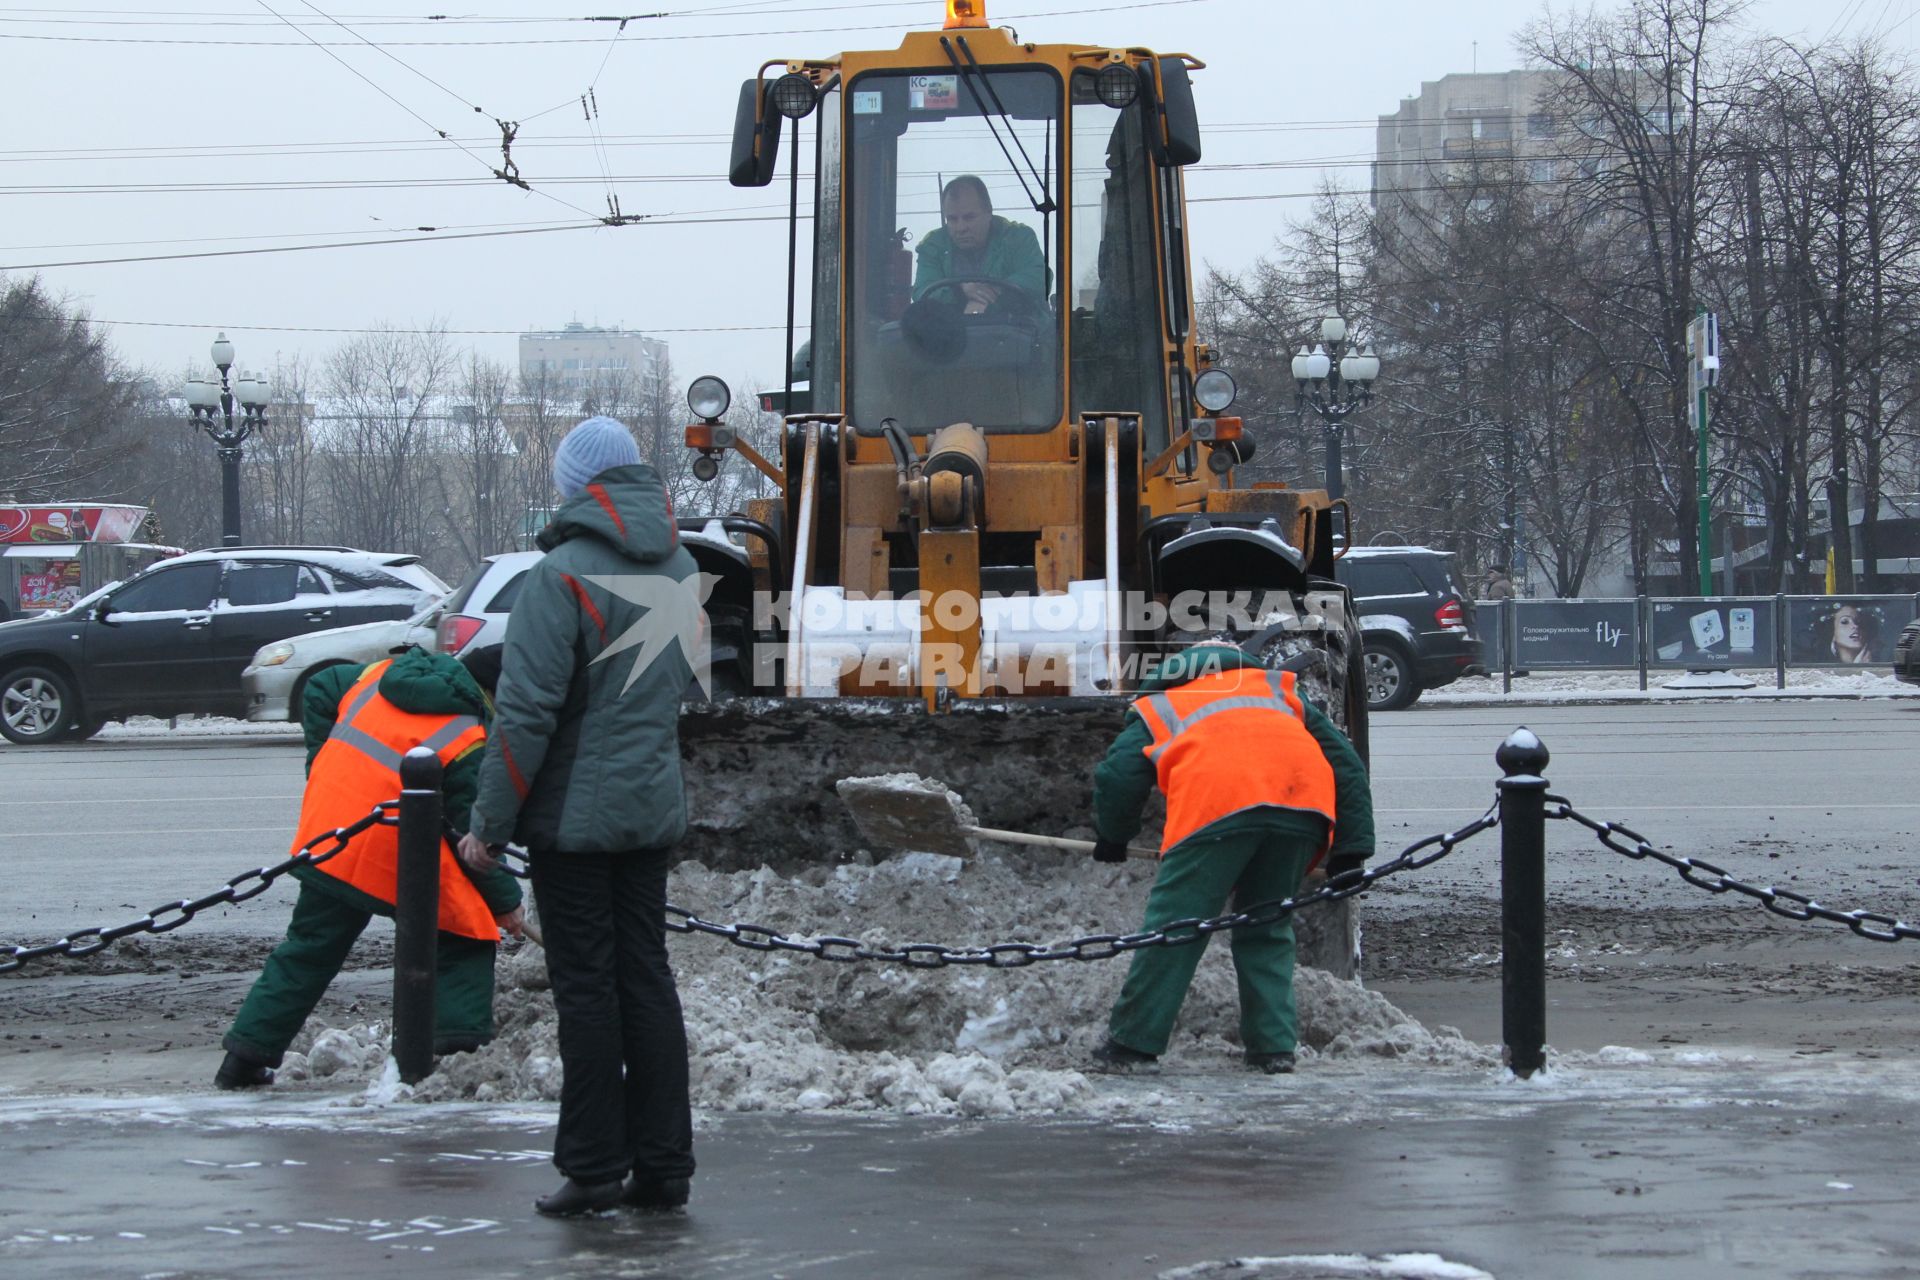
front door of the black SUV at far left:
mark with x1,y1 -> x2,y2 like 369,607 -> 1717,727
83,560 -> 221,716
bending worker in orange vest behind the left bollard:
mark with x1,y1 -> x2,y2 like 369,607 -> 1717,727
213,645 -> 526,1088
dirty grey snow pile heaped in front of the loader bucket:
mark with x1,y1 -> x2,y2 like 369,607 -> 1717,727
284,852 -> 1498,1117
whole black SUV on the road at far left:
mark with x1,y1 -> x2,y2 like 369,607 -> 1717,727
0,547 -> 447,745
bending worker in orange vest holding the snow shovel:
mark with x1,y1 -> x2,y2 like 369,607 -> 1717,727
1092,641 -> 1373,1075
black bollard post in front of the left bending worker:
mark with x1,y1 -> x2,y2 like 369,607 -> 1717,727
394,747 -> 442,1084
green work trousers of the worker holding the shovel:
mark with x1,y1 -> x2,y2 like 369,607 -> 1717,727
1108,831 -> 1319,1055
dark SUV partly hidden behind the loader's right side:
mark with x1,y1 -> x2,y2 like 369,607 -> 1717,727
1334,547 -> 1480,712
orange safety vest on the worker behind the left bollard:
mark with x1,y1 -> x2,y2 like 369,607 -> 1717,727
294,660 -> 499,942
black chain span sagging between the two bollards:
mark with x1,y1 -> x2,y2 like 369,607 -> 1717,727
625,804 -> 1500,969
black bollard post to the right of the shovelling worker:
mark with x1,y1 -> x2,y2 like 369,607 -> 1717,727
1494,727 -> 1548,1080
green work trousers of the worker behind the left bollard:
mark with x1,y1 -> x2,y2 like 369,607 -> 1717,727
223,885 -> 495,1067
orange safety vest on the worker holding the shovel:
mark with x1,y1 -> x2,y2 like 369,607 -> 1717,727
1133,666 -> 1334,856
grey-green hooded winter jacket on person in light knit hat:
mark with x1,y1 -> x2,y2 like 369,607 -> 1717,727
470,462 -> 699,854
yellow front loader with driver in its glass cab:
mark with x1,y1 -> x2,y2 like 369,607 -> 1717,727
682,0 -> 1365,971
